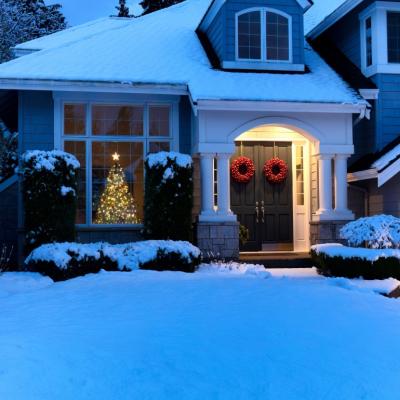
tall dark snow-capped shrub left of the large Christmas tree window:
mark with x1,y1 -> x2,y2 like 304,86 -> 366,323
20,150 -> 80,251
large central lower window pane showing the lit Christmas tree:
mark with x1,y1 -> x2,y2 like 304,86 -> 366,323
92,142 -> 144,224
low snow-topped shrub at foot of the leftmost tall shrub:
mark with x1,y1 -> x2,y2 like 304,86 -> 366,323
25,243 -> 118,281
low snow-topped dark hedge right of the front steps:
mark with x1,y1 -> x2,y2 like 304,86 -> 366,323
311,243 -> 400,279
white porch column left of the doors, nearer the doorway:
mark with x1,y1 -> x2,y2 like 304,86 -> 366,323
217,153 -> 236,220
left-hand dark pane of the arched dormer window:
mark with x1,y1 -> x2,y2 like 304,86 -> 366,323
237,11 -> 261,60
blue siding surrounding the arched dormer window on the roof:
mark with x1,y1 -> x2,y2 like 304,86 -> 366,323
207,0 -> 304,64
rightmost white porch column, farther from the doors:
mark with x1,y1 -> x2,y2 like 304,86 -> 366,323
335,154 -> 354,219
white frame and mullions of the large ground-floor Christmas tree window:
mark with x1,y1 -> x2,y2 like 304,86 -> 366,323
53,92 -> 179,230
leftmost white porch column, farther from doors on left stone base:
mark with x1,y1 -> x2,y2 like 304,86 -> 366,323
199,153 -> 215,221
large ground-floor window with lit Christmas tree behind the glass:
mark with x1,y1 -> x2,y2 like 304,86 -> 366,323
61,102 -> 173,226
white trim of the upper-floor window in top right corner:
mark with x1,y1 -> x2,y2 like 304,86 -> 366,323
359,1 -> 400,77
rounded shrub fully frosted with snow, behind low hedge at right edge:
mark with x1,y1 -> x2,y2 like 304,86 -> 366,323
340,215 -> 400,249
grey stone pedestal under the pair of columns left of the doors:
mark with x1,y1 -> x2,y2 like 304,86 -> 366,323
197,222 -> 239,260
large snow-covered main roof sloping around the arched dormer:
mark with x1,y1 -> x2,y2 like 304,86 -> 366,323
0,0 -> 364,105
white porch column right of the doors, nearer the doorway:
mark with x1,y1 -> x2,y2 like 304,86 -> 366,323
317,154 -> 334,219
